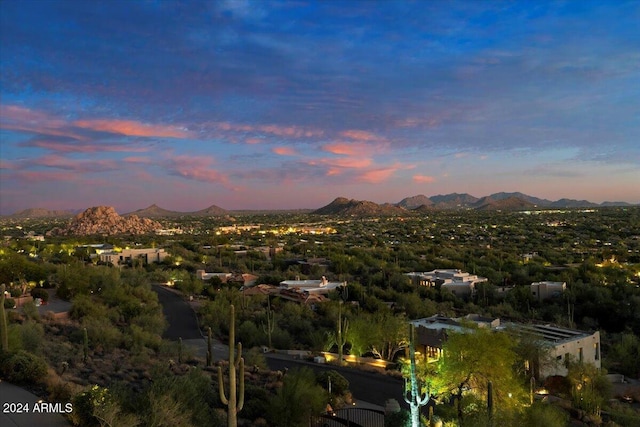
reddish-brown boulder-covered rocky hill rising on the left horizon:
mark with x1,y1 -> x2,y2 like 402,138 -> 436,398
49,206 -> 162,236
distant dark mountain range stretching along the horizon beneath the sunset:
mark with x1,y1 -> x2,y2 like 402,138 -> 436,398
4,192 -> 633,219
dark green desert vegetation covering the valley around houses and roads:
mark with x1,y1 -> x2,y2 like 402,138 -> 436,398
0,207 -> 640,426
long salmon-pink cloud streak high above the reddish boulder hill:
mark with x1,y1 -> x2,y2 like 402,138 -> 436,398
73,119 -> 191,138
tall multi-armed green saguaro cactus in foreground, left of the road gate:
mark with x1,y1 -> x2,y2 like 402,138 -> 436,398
218,305 -> 244,427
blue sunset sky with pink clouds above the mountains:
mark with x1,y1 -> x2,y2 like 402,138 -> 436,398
0,0 -> 640,215
